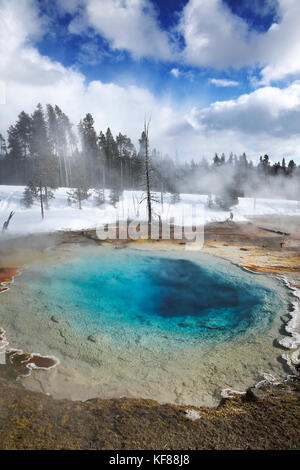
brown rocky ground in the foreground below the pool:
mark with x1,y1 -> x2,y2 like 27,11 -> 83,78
0,379 -> 300,450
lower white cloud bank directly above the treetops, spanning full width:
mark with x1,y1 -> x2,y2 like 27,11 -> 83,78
0,0 -> 300,163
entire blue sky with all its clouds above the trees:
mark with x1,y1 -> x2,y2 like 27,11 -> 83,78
0,0 -> 300,161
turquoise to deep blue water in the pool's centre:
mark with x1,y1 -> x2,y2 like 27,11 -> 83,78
31,250 -> 282,339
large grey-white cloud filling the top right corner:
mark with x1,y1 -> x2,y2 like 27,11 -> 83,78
179,0 -> 300,84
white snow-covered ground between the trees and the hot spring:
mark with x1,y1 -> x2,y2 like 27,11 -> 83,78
0,186 -> 300,236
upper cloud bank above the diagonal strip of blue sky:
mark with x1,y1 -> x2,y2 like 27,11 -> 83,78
53,0 -> 300,84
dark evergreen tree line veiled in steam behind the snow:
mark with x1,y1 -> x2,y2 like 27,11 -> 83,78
0,104 -> 300,215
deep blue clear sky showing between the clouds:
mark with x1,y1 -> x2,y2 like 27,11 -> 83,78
37,0 -> 277,105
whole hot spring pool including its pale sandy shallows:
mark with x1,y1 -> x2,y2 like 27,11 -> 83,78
0,247 -> 289,405
